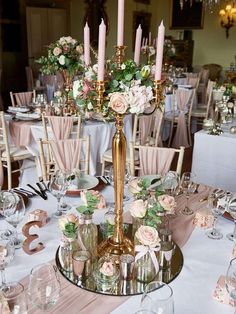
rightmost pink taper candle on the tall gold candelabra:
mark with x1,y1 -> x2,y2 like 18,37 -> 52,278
155,21 -> 165,80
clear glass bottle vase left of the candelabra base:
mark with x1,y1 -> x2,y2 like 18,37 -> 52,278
79,215 -> 98,261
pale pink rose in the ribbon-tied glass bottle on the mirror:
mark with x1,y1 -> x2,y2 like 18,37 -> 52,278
135,226 -> 160,247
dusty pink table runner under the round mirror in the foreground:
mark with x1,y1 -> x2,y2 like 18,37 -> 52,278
18,185 -> 210,314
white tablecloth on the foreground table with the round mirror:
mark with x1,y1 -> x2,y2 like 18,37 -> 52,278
0,186 -> 233,314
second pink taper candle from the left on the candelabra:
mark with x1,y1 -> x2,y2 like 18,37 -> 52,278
97,19 -> 106,81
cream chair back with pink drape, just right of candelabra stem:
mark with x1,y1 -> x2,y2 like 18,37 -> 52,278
130,142 -> 184,176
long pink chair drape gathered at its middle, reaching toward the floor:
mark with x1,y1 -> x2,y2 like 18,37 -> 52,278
172,89 -> 193,148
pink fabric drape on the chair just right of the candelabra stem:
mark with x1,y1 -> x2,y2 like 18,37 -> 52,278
139,146 -> 175,176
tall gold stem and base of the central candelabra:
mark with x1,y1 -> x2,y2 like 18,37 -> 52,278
98,115 -> 134,265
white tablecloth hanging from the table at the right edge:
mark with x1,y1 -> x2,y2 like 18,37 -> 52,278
192,126 -> 236,192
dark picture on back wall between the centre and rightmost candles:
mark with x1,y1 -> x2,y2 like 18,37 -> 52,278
133,11 -> 152,49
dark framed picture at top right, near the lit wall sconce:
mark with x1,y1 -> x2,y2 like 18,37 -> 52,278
170,0 -> 204,29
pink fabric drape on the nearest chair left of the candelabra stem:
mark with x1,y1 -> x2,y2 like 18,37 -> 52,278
49,139 -> 82,171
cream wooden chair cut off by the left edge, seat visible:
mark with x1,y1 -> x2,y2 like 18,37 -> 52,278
0,111 -> 33,190
